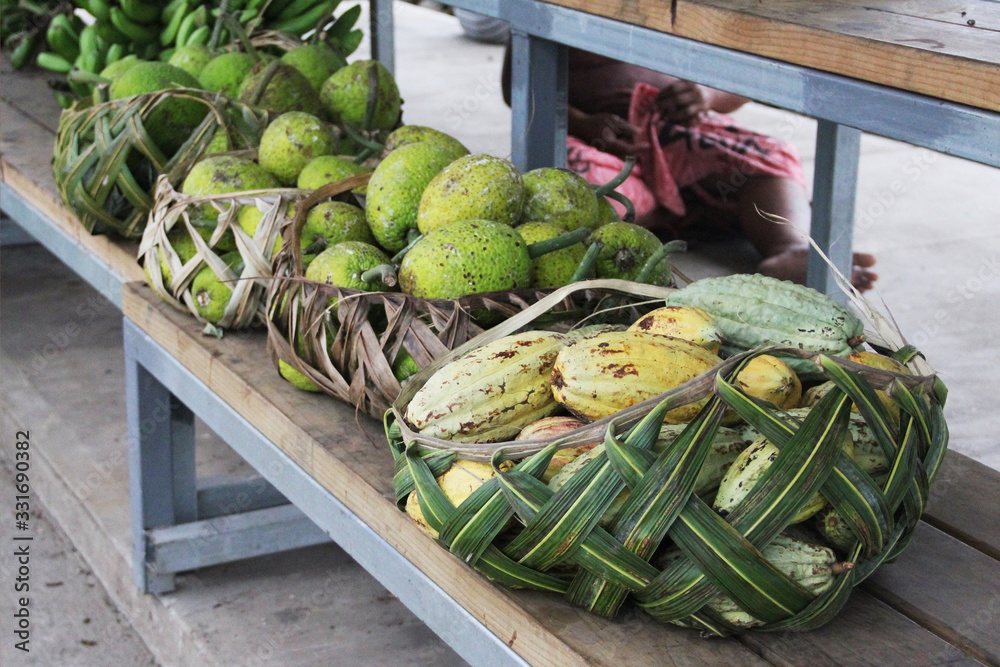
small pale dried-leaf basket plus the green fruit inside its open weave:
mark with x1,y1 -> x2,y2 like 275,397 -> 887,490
138,175 -> 311,334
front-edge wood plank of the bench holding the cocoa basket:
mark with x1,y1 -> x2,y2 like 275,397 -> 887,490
123,284 -> 765,667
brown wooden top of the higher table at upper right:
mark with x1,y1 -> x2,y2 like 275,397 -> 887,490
550,0 -> 1000,111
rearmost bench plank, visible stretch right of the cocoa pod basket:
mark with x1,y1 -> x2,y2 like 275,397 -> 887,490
923,452 -> 1000,560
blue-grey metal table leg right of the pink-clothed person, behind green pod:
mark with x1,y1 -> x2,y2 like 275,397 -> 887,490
806,120 -> 861,302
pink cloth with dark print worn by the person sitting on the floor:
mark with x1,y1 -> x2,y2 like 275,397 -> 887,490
566,83 -> 805,224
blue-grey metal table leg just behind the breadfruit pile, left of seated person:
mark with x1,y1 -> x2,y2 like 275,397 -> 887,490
511,30 -> 569,173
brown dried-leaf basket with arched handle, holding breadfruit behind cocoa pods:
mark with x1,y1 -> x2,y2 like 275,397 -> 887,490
267,180 -> 660,419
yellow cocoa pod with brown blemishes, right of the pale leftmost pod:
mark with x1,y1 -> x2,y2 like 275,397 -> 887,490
552,331 -> 721,424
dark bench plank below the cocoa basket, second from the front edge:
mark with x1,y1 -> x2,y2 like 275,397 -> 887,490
742,592 -> 981,667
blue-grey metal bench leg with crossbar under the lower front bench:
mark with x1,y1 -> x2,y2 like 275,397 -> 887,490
123,319 -> 330,594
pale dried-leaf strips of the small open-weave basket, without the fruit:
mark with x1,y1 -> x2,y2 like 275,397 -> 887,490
139,176 -> 310,330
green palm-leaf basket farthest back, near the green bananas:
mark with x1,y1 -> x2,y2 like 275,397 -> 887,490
52,88 -> 267,238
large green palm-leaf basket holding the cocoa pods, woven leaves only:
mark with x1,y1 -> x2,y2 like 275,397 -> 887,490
386,281 -> 948,635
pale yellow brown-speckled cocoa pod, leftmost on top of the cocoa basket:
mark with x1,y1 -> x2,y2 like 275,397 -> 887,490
406,331 -> 566,442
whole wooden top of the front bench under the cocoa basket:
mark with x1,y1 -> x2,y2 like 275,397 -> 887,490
123,284 -> 1000,666
